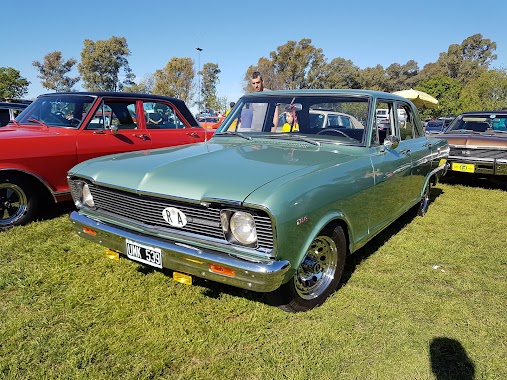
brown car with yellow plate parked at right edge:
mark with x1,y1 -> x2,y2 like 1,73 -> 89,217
439,111 -> 507,178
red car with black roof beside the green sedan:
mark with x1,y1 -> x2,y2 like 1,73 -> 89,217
0,92 -> 212,230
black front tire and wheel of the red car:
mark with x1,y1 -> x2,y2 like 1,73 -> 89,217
0,177 -> 39,230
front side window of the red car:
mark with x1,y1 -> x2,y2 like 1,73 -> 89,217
85,100 -> 138,130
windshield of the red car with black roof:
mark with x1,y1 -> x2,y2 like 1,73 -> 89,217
16,94 -> 95,128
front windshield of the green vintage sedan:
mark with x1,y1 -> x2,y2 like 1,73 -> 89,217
215,91 -> 369,144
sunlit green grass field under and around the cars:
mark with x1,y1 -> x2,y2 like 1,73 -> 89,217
0,183 -> 507,380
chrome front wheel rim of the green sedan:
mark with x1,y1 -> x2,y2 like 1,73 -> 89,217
294,236 -> 338,300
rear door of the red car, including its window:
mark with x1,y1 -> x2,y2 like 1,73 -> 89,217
140,101 -> 206,148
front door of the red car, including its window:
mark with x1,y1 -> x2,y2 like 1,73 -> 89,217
76,98 -> 152,162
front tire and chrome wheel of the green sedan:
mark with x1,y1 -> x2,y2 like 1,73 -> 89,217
267,226 -> 347,312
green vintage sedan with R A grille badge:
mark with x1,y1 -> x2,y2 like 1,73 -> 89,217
68,90 -> 449,311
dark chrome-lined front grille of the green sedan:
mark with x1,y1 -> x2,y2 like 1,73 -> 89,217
79,181 -> 273,250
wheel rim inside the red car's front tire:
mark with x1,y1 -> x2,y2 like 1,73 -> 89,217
0,182 -> 28,226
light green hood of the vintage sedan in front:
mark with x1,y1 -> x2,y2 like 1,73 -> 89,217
69,140 -> 355,202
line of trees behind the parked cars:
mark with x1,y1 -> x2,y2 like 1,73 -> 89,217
0,34 -> 507,116
